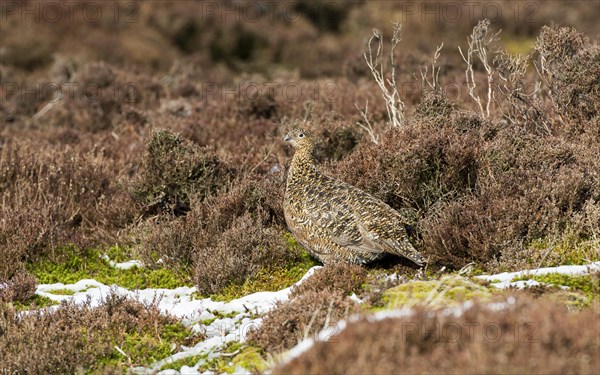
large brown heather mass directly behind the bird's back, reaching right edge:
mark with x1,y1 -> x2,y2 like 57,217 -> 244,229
328,72 -> 600,269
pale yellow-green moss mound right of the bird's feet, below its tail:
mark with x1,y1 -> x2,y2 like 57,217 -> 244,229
383,275 -> 493,308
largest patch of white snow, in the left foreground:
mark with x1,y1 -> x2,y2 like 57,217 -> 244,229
36,262 -> 321,374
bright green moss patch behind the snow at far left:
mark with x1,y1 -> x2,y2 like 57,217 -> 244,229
27,247 -> 191,289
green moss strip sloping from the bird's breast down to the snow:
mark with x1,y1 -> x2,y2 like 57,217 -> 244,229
210,238 -> 318,301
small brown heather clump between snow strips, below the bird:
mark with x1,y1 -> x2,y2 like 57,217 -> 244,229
248,289 -> 357,353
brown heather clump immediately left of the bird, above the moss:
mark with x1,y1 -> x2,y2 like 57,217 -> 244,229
138,172 -> 299,294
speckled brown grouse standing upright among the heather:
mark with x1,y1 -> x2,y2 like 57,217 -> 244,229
284,128 -> 425,265
